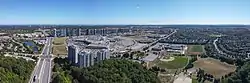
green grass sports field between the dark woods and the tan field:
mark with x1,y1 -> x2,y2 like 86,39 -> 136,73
157,56 -> 188,69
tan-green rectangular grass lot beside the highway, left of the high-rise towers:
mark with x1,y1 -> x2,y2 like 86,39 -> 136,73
52,37 -> 67,55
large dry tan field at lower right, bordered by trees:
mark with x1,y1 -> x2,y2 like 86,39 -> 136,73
194,58 -> 236,78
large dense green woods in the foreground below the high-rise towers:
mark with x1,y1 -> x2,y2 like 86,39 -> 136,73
52,58 -> 160,83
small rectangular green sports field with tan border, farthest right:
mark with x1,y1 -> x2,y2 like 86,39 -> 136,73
187,45 -> 204,54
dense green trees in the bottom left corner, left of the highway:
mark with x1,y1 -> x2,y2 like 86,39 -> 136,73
0,55 -> 35,83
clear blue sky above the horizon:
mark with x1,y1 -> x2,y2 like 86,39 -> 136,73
0,0 -> 250,25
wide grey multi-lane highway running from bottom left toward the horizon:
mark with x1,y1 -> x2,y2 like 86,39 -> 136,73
29,37 -> 52,83
